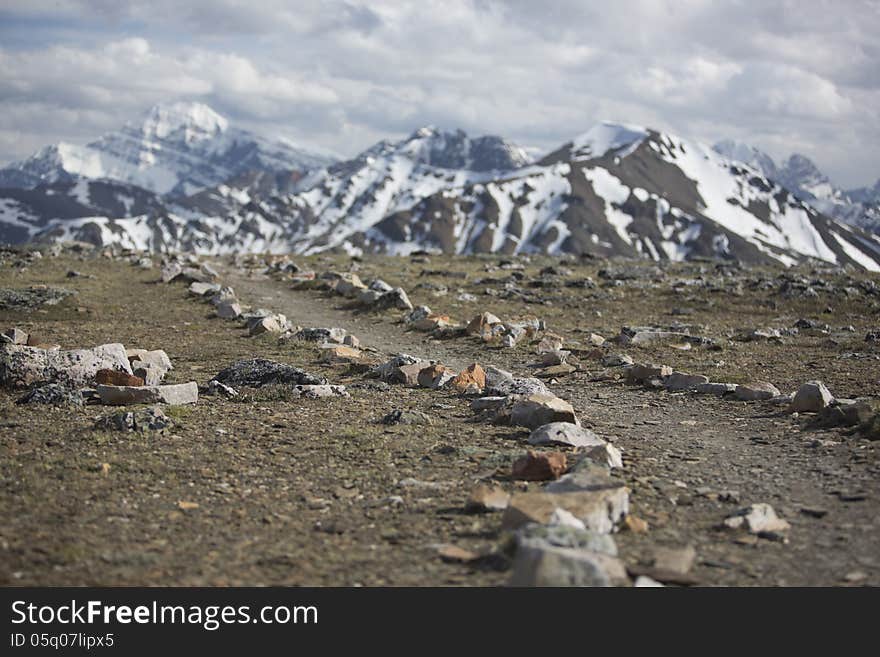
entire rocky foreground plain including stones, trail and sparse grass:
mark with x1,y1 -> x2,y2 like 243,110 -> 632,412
0,244 -> 880,586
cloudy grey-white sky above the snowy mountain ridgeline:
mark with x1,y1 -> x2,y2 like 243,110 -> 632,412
0,0 -> 880,187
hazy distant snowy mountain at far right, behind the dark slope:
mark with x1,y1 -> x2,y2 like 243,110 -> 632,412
714,140 -> 880,233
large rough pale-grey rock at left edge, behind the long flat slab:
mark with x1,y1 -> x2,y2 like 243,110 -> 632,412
0,343 -> 131,388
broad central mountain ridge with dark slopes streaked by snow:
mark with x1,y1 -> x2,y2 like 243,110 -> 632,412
15,123 -> 880,271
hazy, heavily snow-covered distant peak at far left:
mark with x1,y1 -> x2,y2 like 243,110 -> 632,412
0,102 -> 333,196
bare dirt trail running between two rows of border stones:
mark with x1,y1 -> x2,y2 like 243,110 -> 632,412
223,260 -> 880,585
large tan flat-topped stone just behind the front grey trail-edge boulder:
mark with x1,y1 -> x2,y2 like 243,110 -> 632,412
501,486 -> 629,534
